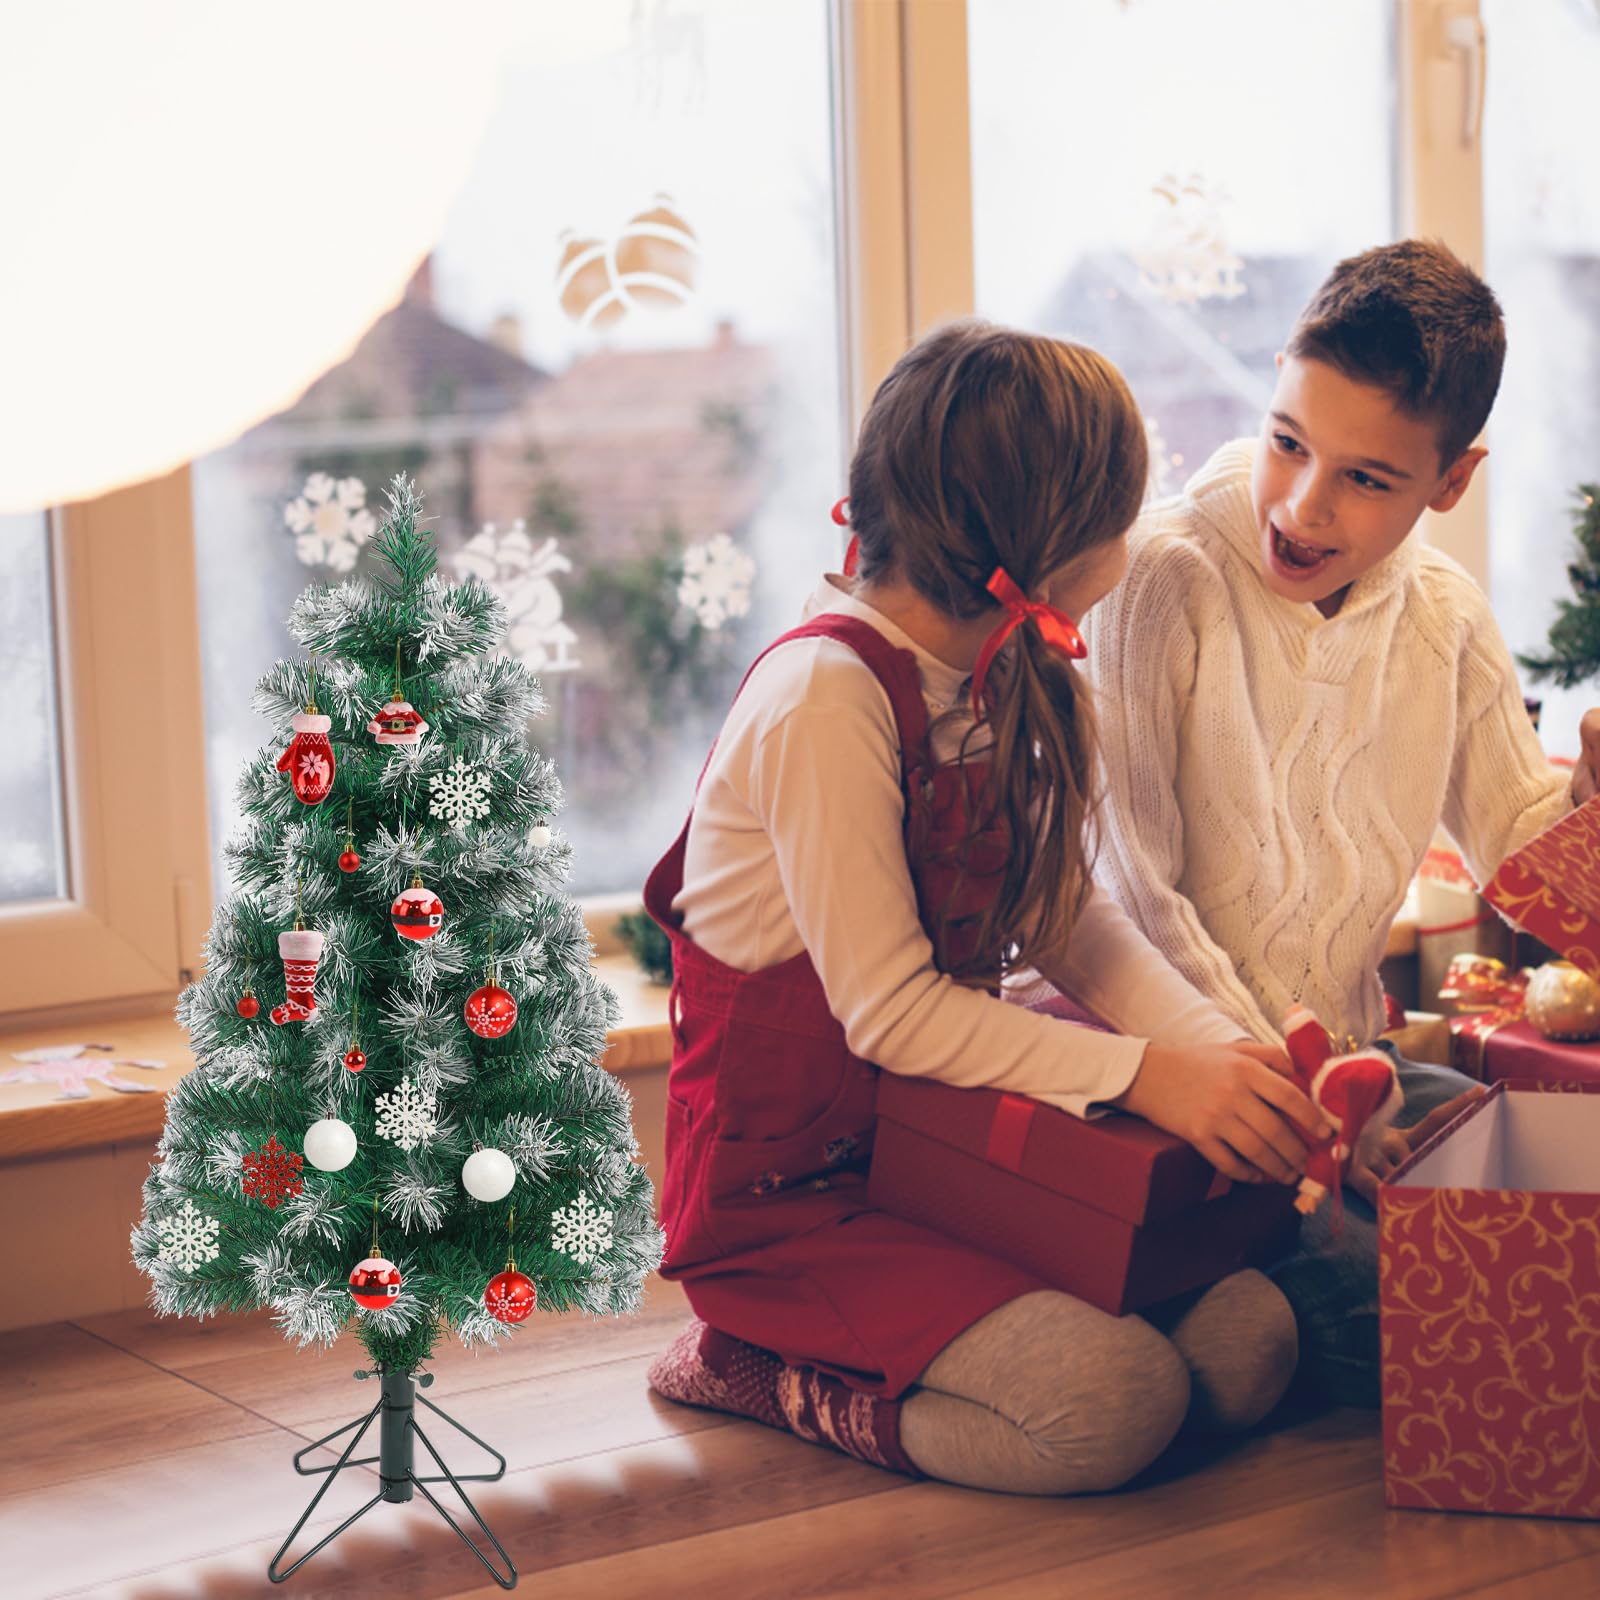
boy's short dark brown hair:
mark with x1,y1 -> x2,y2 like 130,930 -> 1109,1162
1286,238 -> 1506,467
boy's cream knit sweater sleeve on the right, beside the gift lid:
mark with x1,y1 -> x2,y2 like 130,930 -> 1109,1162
1429,566 -> 1571,885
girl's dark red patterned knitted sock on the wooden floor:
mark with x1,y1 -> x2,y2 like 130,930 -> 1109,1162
646,1322 -> 922,1477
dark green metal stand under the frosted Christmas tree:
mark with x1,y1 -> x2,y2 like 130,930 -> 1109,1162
267,1368 -> 517,1589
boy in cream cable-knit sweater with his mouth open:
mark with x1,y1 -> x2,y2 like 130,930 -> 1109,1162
1088,240 -> 1600,1403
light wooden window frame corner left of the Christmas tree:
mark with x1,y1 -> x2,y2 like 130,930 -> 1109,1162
0,469 -> 211,1027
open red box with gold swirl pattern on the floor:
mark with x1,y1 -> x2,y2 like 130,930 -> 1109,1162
1378,1083 -> 1600,1518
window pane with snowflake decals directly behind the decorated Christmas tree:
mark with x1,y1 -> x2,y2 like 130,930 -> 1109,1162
194,0 -> 842,894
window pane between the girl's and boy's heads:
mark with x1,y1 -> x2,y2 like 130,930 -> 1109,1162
966,0 -> 1395,491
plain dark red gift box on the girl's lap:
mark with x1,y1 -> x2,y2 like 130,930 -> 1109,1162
867,1072 -> 1299,1315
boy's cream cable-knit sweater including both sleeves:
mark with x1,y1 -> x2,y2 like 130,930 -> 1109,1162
1086,440 -> 1570,1040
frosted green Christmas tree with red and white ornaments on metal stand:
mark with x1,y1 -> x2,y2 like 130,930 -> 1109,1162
133,478 -> 661,1586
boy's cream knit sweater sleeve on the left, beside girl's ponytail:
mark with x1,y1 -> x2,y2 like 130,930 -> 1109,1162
1088,536 -> 1278,1043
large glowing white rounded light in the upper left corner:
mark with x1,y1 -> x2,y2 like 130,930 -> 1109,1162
0,0 -> 627,512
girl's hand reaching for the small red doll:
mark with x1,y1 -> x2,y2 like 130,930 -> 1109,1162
1112,1042 -> 1333,1184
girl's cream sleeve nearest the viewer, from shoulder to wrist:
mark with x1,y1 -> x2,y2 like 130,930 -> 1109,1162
749,658 -> 1147,1117
